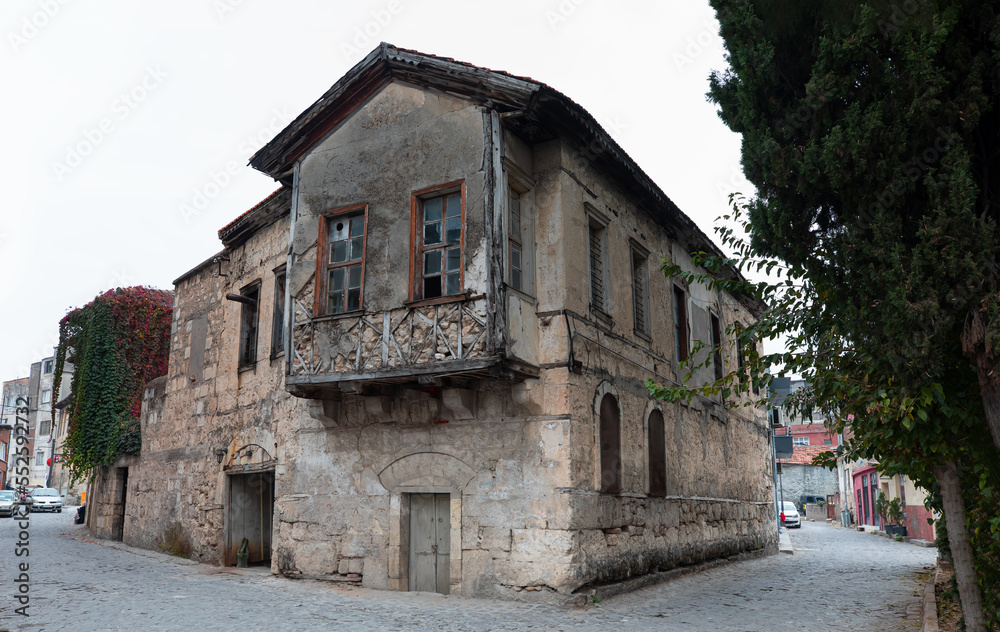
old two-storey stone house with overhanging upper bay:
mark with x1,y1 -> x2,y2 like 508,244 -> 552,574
94,44 -> 776,598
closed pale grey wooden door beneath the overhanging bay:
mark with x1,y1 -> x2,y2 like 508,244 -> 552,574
410,494 -> 451,595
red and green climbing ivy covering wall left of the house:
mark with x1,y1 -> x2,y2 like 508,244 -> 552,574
53,287 -> 173,480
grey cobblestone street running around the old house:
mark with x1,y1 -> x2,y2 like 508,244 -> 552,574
0,508 -> 936,632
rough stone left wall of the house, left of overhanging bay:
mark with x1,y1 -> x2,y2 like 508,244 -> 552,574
125,211 -> 305,564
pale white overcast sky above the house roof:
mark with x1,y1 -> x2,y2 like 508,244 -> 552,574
0,0 -> 751,380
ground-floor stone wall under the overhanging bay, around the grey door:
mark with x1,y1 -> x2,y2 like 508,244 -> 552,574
276,381 -> 571,596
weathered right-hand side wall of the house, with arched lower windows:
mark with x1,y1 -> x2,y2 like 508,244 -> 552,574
534,135 -> 775,583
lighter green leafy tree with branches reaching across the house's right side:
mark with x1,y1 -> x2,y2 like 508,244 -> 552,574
647,204 -> 1000,630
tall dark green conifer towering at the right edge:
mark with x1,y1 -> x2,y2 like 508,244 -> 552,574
709,0 -> 1000,629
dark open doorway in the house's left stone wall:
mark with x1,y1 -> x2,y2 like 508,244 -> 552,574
226,472 -> 274,565
